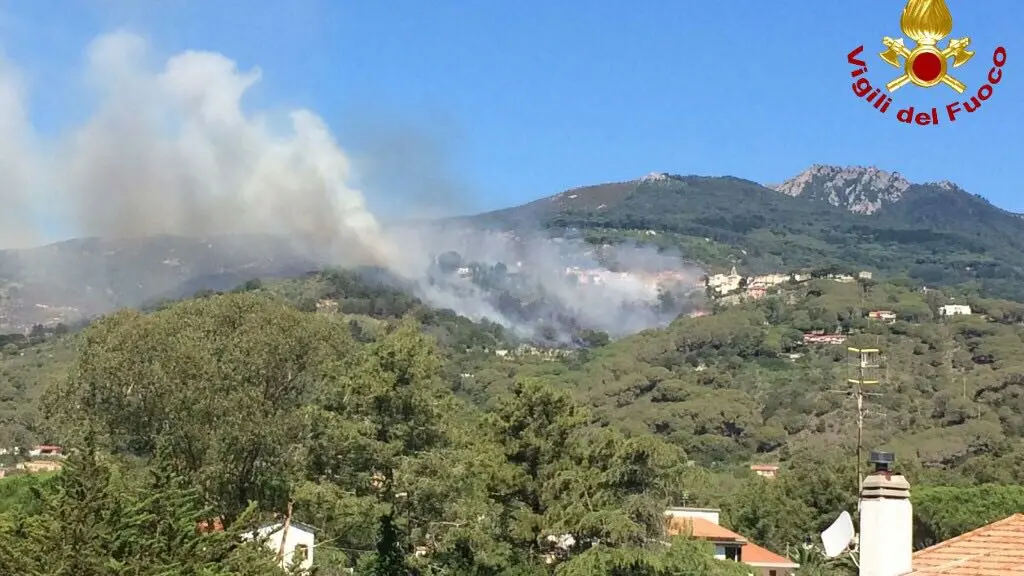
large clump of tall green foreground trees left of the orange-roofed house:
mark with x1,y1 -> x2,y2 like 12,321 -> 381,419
0,284 -> 742,575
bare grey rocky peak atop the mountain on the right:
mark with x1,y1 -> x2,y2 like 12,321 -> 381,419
768,164 -> 913,214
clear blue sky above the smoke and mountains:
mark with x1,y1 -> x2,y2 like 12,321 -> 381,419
0,0 -> 1024,211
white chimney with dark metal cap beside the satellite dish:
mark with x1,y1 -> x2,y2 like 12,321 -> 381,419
859,452 -> 913,576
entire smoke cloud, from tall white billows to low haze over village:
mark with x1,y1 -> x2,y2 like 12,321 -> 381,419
0,33 -> 699,333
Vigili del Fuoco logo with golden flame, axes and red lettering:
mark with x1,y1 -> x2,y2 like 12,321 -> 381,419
846,0 -> 1007,126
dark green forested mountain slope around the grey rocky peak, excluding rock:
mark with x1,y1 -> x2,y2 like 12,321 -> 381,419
470,174 -> 1024,300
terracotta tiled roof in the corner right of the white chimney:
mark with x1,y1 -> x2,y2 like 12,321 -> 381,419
907,513 -> 1024,576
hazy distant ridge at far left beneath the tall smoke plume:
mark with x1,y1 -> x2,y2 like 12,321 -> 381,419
0,235 -> 317,331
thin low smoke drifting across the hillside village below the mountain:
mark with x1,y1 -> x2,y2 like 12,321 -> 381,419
385,227 -> 703,343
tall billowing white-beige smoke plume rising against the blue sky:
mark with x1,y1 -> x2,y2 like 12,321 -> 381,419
59,33 -> 388,263
